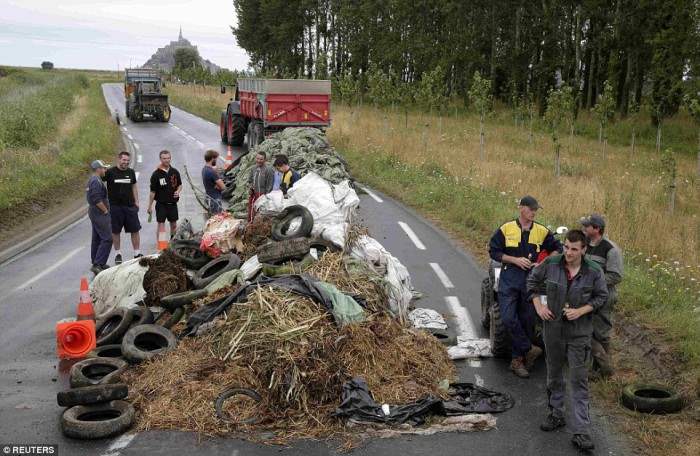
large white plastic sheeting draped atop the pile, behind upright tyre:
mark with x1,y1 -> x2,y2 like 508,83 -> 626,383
255,172 -> 360,248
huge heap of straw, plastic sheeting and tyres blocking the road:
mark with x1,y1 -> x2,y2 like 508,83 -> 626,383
76,129 -> 513,443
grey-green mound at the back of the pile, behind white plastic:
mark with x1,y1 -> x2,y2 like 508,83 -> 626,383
224,128 -> 351,218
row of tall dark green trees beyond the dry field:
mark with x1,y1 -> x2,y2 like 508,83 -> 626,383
233,0 -> 700,123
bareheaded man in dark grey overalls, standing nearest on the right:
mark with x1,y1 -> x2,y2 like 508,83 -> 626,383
527,230 -> 608,450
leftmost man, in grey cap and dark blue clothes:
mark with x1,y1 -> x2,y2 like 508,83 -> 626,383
86,160 -> 112,275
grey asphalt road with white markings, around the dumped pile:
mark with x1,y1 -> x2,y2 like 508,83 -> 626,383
0,84 -> 631,456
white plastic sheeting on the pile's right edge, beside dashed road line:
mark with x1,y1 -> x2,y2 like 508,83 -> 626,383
350,235 -> 413,321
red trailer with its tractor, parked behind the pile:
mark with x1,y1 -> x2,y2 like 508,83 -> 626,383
219,78 -> 331,148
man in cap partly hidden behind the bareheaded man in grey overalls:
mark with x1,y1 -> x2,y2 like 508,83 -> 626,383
581,214 -> 623,377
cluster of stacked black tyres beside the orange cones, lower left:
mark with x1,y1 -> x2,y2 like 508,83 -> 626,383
56,305 -> 177,439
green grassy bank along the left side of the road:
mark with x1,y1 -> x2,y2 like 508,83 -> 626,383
0,70 -> 120,237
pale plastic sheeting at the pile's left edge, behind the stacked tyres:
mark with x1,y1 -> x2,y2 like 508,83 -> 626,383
90,255 -> 153,318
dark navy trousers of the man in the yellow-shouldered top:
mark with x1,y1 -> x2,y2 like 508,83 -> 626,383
498,270 -> 535,358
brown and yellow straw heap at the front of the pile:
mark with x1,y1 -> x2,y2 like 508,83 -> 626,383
127,254 -> 454,442
